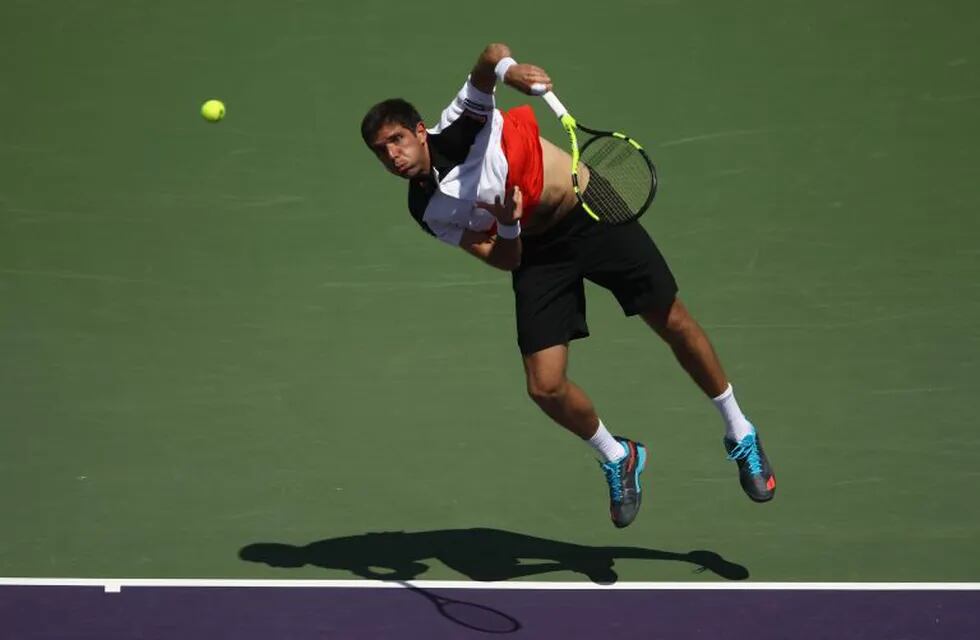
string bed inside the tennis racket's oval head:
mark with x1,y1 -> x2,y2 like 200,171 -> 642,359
581,136 -> 656,224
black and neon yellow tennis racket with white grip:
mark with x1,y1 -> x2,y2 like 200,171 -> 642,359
532,85 -> 657,224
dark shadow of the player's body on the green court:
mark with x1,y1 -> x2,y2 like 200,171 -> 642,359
238,529 -> 749,584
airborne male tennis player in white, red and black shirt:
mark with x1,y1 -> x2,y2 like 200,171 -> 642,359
361,44 -> 776,527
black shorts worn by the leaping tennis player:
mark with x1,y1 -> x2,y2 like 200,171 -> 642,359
513,206 -> 677,355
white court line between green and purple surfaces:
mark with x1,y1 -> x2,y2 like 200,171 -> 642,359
0,578 -> 980,593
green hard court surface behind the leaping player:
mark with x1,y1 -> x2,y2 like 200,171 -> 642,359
0,0 -> 980,582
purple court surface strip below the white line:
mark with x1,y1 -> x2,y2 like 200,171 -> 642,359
0,581 -> 980,640
